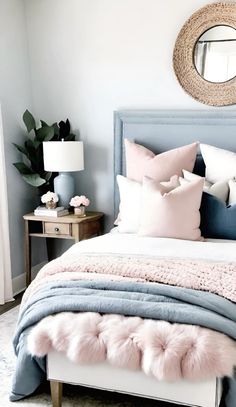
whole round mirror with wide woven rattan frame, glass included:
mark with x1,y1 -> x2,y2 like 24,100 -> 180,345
173,2 -> 236,106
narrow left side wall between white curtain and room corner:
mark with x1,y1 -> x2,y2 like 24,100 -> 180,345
0,0 -> 43,284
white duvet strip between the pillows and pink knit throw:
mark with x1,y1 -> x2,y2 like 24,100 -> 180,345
65,229 -> 236,262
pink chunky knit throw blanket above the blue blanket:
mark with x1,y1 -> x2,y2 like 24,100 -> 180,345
23,253 -> 236,302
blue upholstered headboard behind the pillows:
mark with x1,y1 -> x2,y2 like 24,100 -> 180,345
114,110 -> 236,215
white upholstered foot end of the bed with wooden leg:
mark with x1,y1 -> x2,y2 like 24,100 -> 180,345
47,352 -> 221,407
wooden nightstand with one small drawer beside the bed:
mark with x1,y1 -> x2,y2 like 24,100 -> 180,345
23,212 -> 103,287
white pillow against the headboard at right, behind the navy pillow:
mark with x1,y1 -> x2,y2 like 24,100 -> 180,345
200,144 -> 236,183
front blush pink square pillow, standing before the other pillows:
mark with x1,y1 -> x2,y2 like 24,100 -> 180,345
139,177 -> 204,240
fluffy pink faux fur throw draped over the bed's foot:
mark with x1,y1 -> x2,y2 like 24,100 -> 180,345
28,312 -> 236,381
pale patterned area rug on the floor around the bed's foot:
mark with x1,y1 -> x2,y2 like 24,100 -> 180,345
0,306 -> 176,407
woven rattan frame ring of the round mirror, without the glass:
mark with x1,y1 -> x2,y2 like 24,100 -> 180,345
173,2 -> 236,106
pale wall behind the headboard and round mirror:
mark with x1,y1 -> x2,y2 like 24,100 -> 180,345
25,0 -> 232,231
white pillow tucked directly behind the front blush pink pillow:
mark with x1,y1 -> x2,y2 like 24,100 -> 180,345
115,175 -> 180,233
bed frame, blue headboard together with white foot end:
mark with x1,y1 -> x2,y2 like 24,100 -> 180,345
47,109 -> 236,407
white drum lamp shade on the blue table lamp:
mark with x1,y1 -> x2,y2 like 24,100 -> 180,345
43,141 -> 84,172
